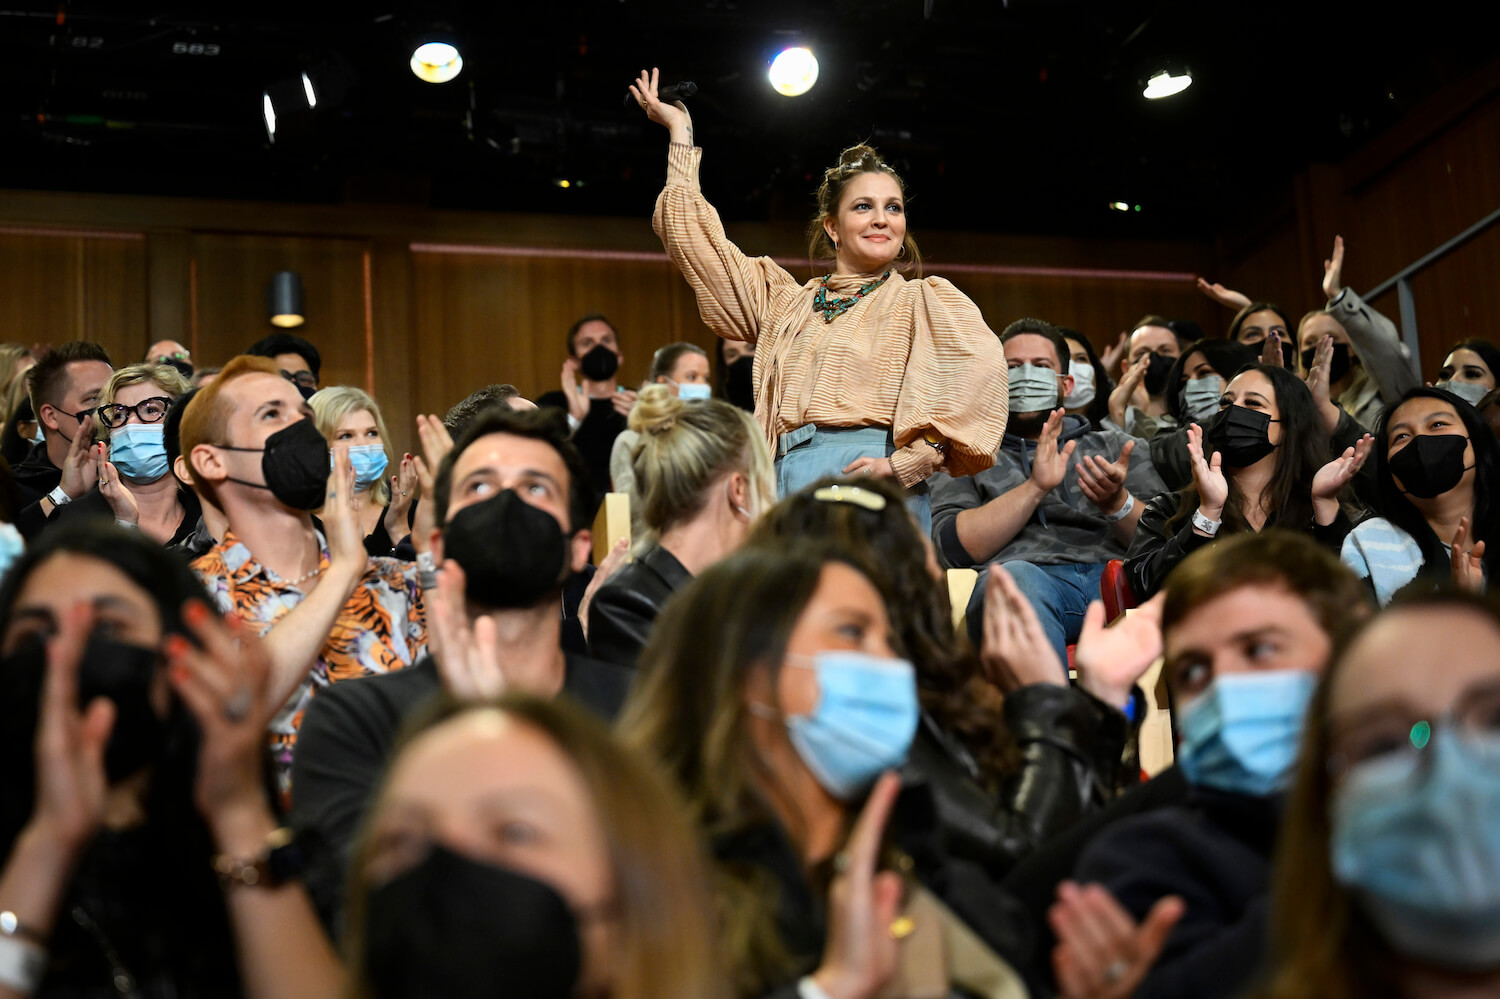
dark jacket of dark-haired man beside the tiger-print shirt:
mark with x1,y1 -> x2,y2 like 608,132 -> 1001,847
291,653 -> 632,935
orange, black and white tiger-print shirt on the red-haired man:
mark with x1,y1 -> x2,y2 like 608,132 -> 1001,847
192,531 -> 428,807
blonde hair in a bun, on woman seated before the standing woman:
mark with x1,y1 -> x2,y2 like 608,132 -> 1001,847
630,386 -> 776,551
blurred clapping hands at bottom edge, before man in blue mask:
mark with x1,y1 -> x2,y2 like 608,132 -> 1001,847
1047,881 -> 1187,999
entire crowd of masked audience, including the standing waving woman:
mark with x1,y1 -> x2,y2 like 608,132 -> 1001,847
0,72 -> 1500,999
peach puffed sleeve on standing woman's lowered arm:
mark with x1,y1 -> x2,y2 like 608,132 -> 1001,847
893,278 -> 1010,476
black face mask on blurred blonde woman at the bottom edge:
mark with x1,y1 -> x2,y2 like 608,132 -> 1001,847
365,846 -> 584,999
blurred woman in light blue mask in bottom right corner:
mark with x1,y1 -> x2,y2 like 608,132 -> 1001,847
1251,594 -> 1500,999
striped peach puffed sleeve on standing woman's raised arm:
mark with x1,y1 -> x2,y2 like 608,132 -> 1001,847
651,143 -> 798,344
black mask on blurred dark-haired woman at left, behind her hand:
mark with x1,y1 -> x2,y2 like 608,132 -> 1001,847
0,635 -> 167,785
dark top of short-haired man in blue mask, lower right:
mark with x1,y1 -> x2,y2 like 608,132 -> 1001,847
1077,788 -> 1281,999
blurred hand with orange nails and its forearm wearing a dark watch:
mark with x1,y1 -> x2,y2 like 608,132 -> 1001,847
167,600 -> 344,999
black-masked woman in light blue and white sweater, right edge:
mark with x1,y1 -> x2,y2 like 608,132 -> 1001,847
1343,389 -> 1500,606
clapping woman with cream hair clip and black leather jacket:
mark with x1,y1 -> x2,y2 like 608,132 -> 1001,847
747,479 -> 1160,875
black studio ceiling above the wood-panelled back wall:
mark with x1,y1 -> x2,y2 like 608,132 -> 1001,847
0,0 -> 1496,237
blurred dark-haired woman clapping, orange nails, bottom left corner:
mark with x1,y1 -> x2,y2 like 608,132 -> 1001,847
0,524 -> 341,999
